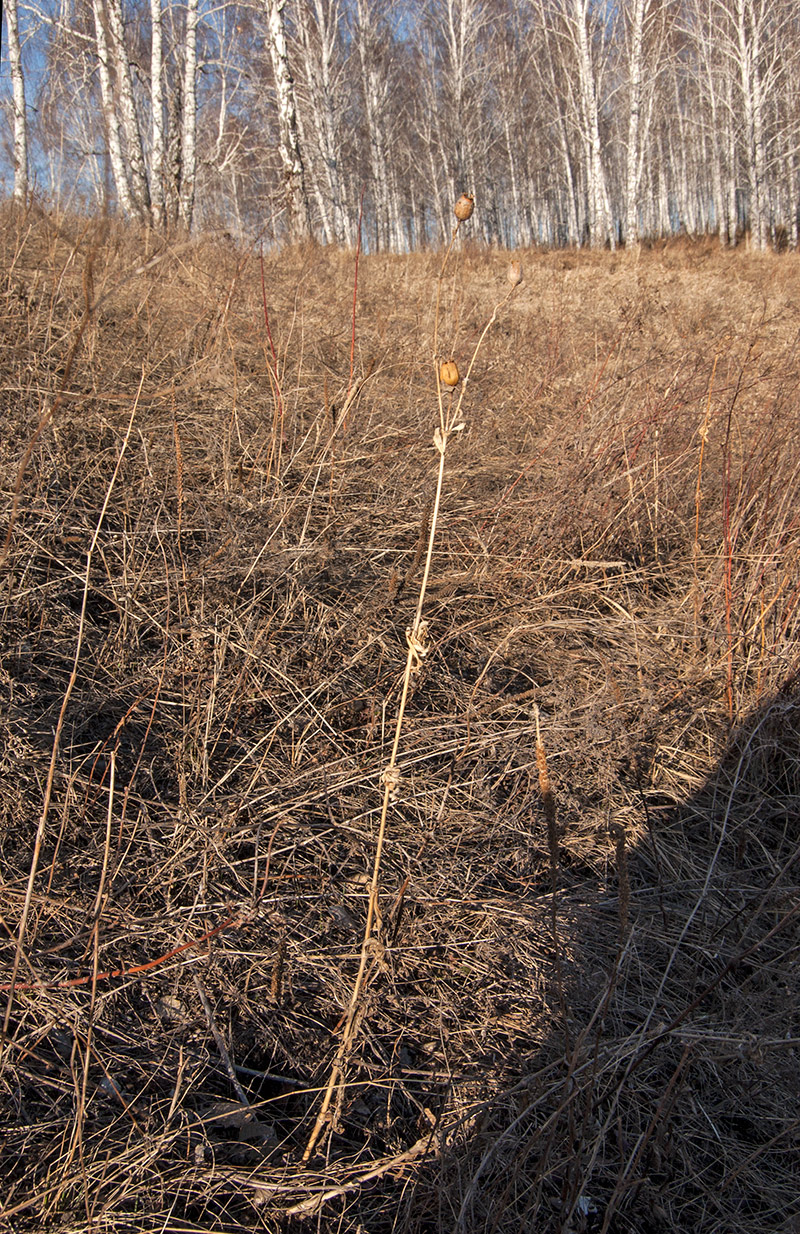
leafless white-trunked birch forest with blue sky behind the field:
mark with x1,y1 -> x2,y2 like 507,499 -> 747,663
0,0 -> 800,252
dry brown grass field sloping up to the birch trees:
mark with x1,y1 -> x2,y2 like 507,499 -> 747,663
0,207 -> 800,1234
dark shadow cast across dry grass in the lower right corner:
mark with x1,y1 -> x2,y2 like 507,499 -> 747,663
313,675 -> 800,1234
